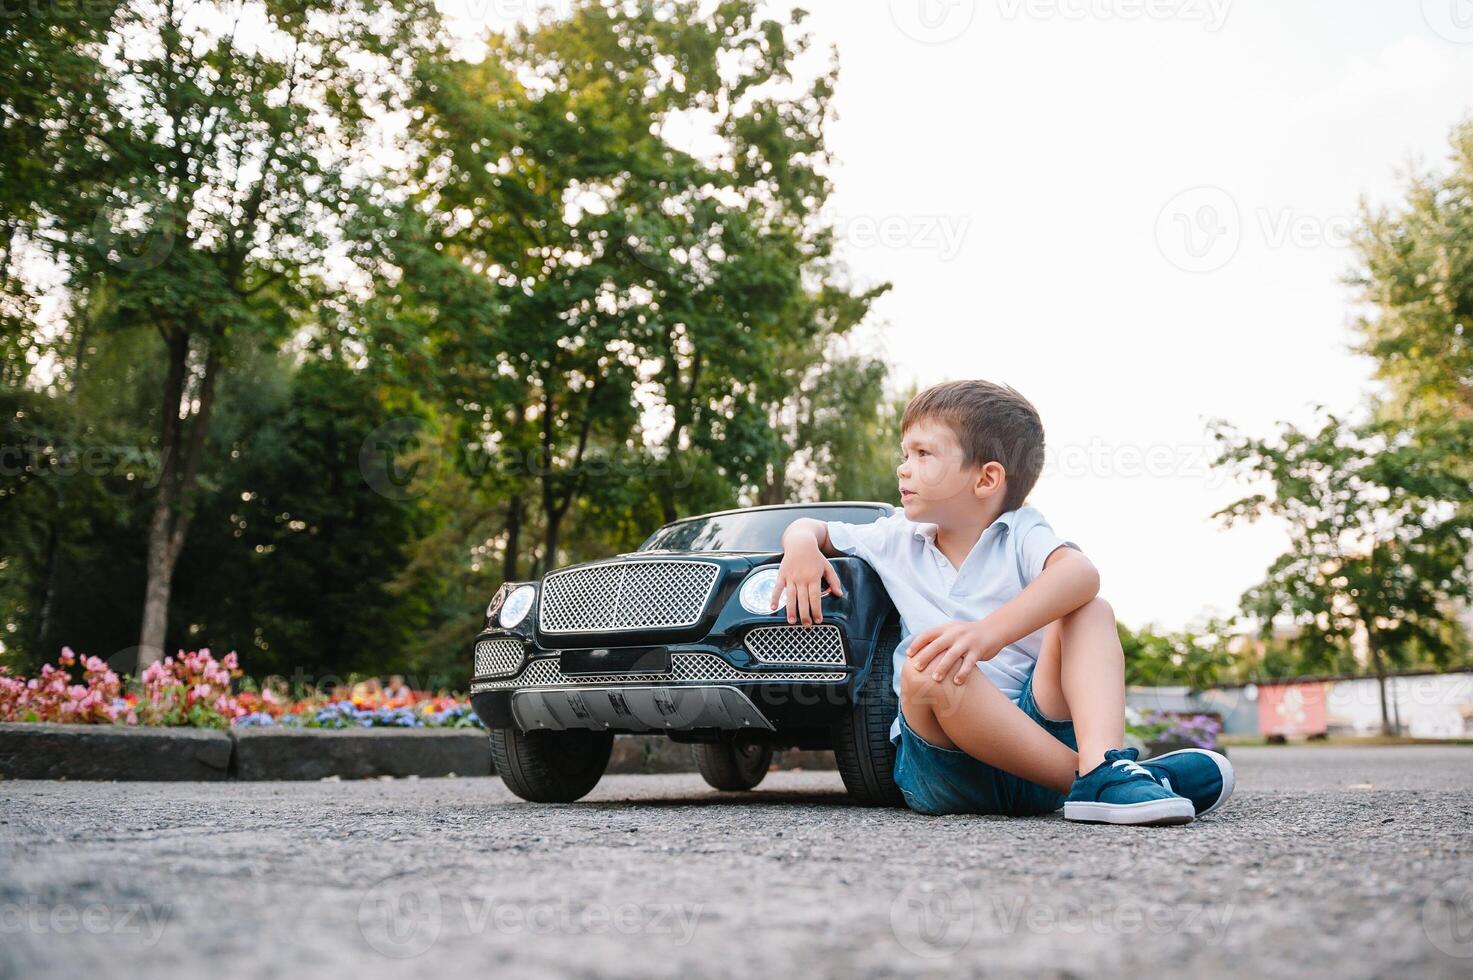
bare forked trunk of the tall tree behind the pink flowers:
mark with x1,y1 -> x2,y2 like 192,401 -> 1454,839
138,335 -> 219,672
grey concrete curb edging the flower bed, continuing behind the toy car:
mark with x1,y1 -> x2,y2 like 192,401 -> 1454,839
0,722 -> 834,781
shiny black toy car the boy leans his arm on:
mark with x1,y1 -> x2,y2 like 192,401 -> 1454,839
471,503 -> 901,806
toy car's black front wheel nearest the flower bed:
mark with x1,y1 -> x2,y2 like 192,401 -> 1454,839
491,728 -> 614,803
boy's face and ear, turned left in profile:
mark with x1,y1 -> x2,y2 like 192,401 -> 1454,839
896,420 -> 1002,525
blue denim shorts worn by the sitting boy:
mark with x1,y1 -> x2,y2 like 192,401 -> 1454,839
896,675 -> 1078,816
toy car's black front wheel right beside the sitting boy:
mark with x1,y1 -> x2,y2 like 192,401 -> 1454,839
834,625 -> 906,806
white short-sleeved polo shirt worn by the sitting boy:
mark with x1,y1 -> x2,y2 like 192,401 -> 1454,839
826,507 -> 1080,740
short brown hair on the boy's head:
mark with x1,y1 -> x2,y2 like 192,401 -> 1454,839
900,380 -> 1043,511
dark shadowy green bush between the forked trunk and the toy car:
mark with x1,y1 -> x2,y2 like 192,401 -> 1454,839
172,357 -> 437,675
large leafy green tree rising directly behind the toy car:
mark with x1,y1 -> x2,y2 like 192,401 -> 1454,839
390,0 -> 878,578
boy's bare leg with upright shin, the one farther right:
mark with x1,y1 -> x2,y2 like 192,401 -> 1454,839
1025,598 -> 1125,772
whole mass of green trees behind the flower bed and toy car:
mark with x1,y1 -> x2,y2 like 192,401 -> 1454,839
0,0 -> 894,685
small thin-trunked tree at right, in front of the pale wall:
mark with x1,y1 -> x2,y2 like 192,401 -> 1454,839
1215,414 -> 1473,734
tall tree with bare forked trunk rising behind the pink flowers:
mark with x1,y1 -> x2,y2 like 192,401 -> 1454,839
31,0 -> 435,665
